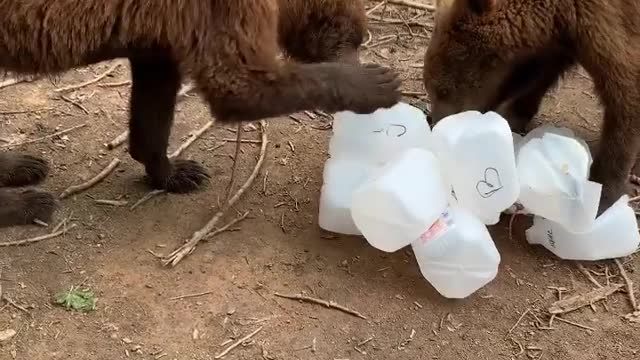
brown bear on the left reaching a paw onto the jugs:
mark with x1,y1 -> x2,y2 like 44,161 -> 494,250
0,0 -> 400,223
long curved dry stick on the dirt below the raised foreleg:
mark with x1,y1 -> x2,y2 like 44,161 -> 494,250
163,120 -> 268,266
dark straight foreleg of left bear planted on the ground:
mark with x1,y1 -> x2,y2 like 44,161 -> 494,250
129,58 -> 209,193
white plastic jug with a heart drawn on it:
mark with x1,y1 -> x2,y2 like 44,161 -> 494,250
432,111 -> 520,225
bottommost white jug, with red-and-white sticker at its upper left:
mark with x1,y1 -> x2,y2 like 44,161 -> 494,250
411,207 -> 500,299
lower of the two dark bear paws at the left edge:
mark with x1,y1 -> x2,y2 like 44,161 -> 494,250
0,189 -> 57,227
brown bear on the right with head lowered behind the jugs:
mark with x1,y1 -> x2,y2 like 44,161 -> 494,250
424,0 -> 640,213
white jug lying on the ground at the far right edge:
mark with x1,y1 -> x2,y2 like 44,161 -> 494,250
526,195 -> 640,261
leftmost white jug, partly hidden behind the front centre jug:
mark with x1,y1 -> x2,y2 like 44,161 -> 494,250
318,157 -> 377,235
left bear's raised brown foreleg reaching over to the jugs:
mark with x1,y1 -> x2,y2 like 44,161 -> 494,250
198,63 -> 400,122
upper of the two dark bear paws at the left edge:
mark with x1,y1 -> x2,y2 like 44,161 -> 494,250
0,152 -> 49,187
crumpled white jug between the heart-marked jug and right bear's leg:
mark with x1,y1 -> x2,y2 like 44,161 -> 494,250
517,127 -> 602,232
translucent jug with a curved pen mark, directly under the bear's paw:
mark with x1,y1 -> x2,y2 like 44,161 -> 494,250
329,103 -> 431,165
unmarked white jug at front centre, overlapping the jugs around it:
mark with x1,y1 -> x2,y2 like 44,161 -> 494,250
351,148 -> 449,252
